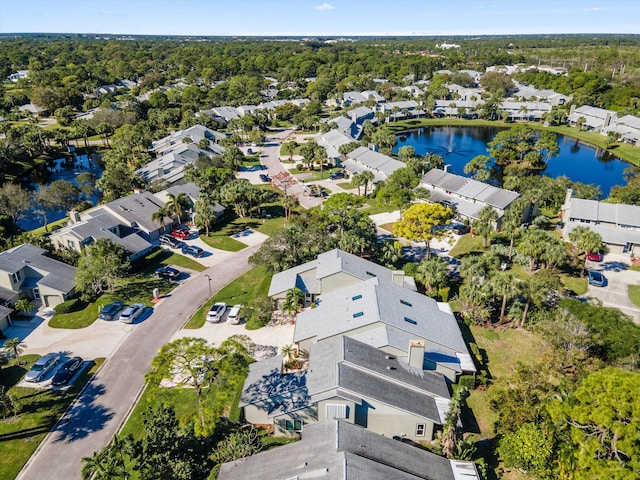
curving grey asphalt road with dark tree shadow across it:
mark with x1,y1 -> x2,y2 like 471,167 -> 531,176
16,245 -> 259,480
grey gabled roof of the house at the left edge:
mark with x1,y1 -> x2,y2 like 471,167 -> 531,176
0,243 -> 76,293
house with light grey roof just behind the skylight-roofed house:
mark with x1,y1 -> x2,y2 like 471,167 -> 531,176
268,248 -> 416,308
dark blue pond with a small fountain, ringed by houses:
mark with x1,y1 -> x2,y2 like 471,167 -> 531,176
393,127 -> 631,198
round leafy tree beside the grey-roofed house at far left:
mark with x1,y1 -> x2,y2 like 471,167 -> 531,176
76,238 -> 130,298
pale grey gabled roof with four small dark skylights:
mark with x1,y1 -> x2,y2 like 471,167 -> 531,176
293,278 -> 468,354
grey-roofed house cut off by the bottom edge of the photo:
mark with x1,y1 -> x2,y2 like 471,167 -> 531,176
218,420 -> 481,480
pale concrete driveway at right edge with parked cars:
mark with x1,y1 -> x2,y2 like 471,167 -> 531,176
585,253 -> 640,324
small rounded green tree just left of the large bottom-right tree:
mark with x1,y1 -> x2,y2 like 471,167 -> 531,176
498,422 -> 553,477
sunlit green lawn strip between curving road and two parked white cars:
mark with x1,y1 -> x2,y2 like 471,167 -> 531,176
184,266 -> 271,328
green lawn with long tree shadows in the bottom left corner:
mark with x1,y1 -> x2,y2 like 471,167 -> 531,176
0,355 -> 104,479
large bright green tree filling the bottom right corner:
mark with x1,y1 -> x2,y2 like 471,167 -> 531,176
549,368 -> 640,480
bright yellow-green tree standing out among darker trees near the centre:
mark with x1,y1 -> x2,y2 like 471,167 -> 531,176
393,203 -> 453,258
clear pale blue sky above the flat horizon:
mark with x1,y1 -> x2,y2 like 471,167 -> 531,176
0,0 -> 640,36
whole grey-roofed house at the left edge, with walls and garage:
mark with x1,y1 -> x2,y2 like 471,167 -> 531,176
0,243 -> 76,316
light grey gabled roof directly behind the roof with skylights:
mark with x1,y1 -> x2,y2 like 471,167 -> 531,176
268,248 -> 416,297
